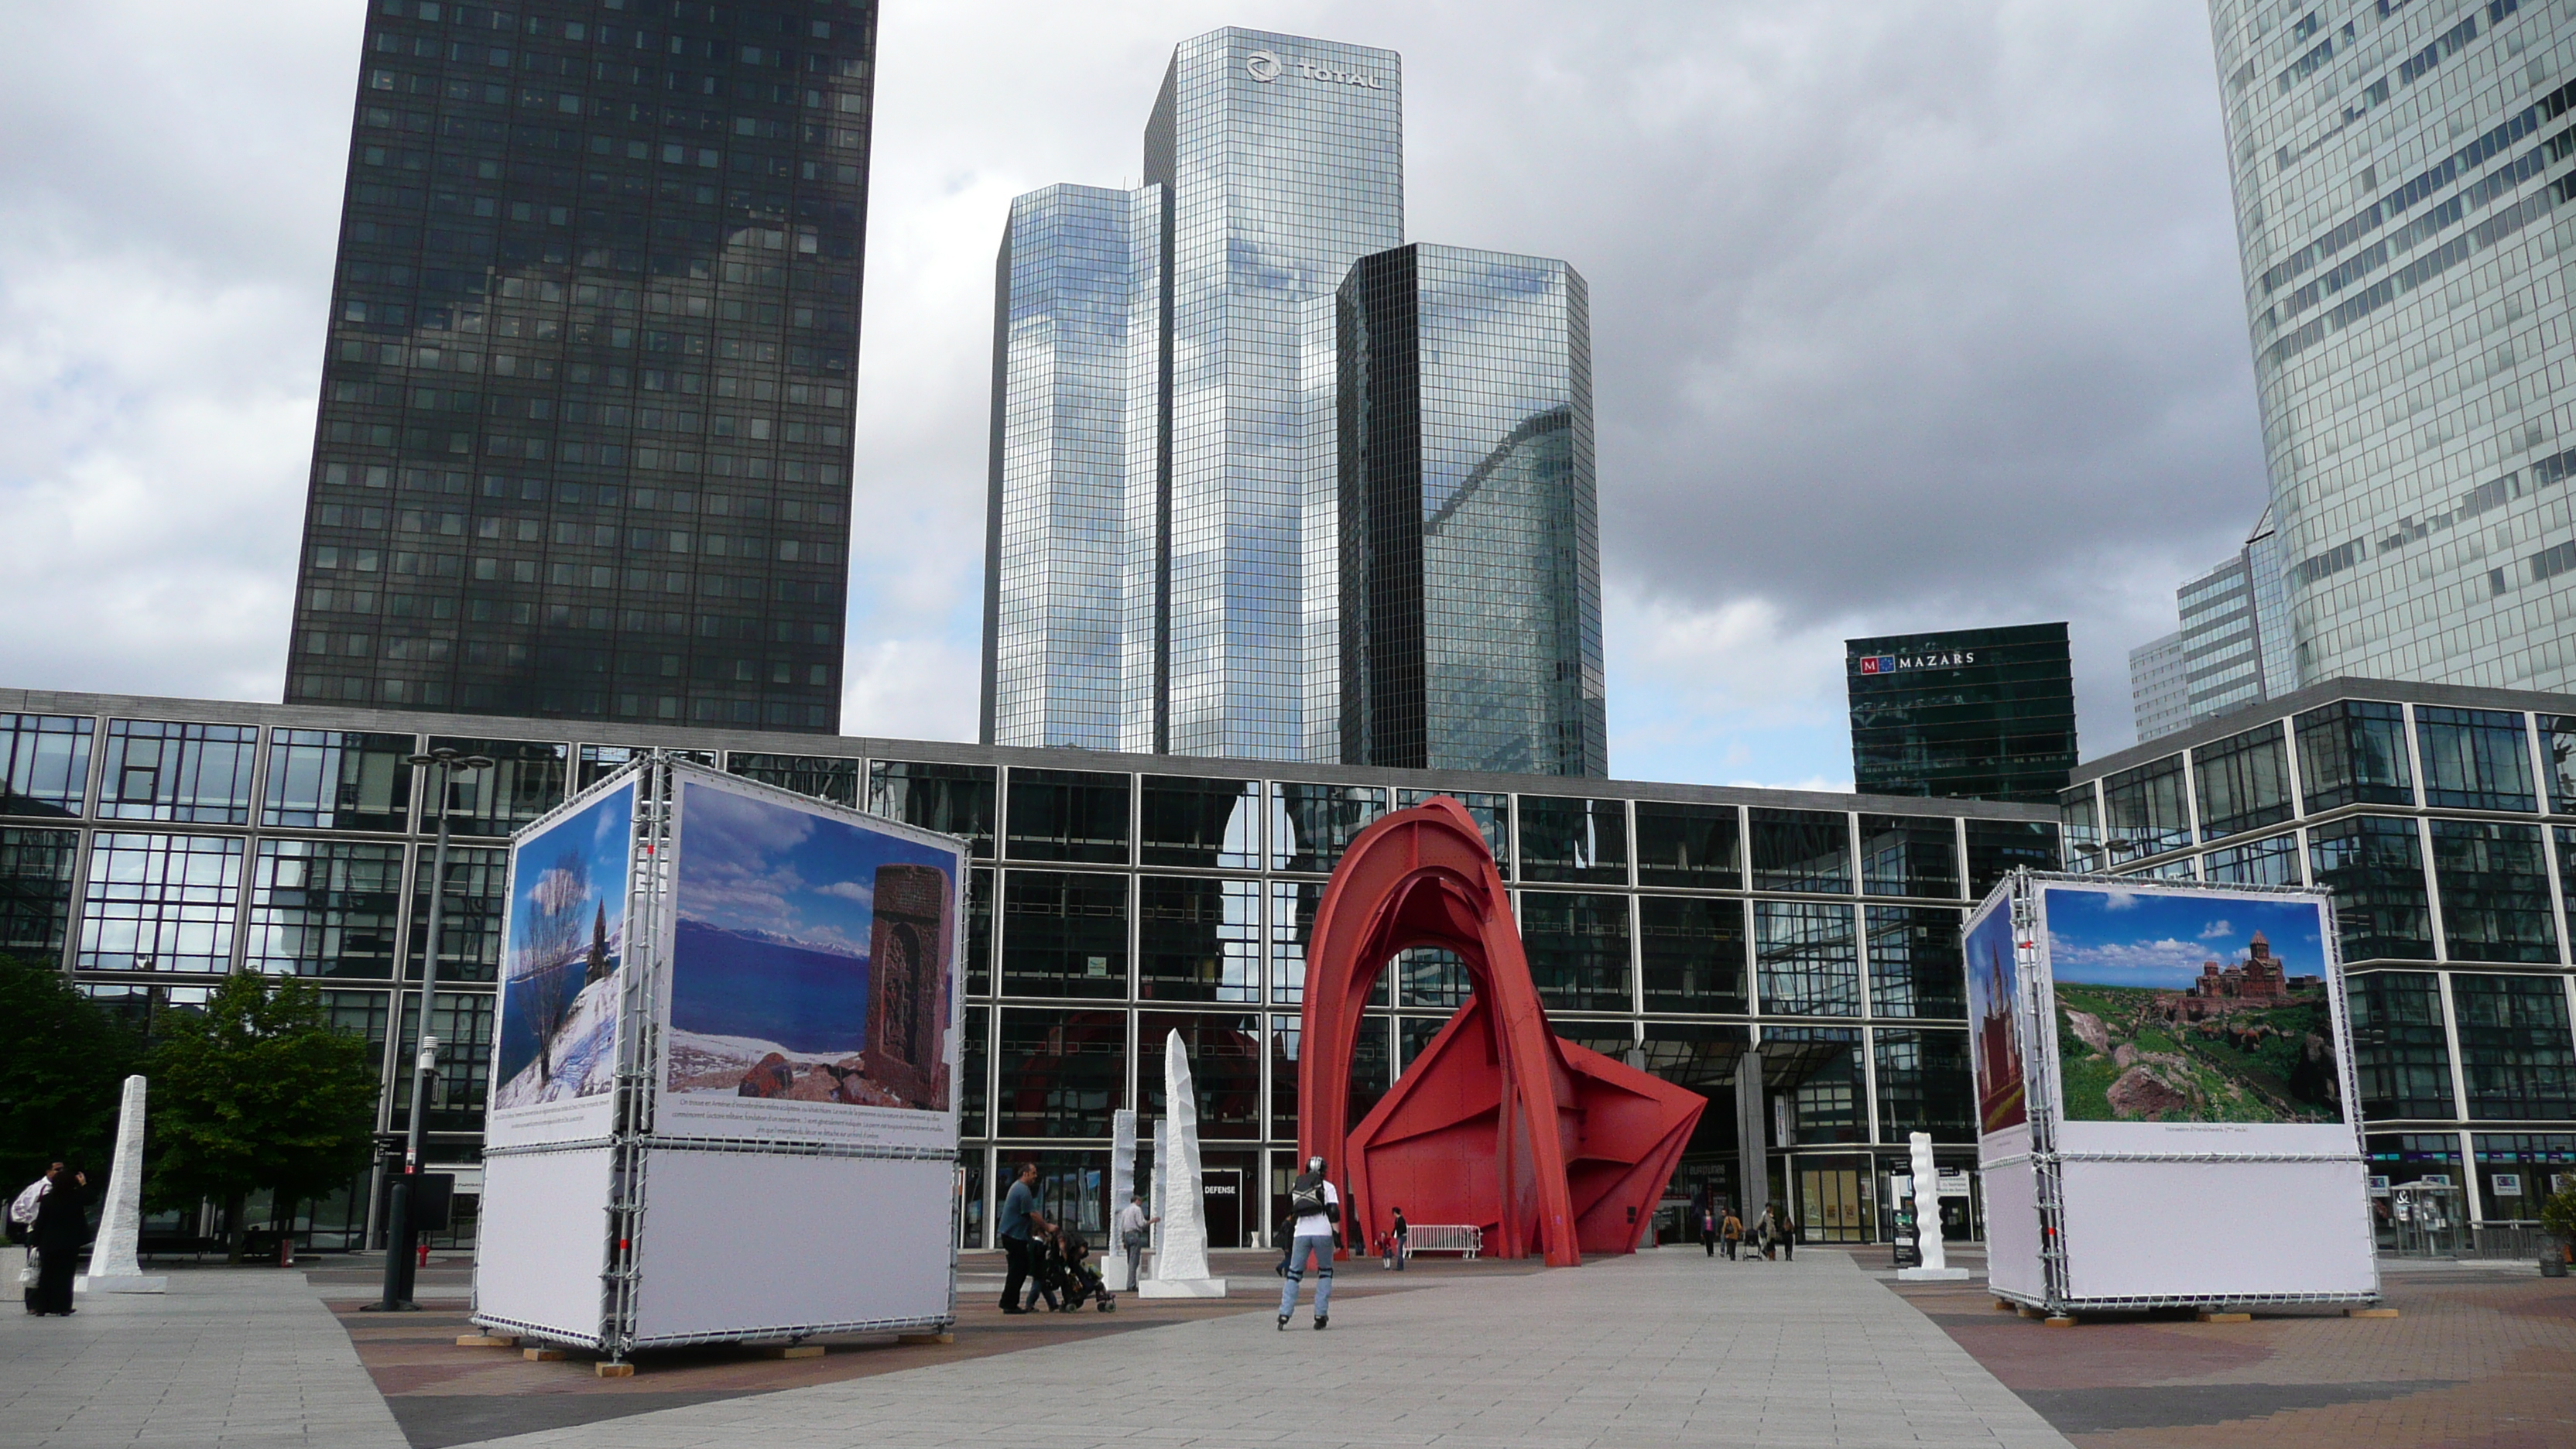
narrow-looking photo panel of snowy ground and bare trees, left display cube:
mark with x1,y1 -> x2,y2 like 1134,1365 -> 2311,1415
489,781 -> 636,1145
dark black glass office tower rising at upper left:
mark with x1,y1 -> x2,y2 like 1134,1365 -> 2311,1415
286,0 -> 876,730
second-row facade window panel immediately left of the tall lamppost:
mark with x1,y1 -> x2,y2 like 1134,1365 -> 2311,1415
247,841 -> 402,980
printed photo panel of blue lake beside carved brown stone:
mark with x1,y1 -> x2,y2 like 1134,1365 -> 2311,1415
662,776 -> 958,1139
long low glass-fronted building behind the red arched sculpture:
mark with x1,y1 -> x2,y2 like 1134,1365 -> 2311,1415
0,691 -> 2050,1245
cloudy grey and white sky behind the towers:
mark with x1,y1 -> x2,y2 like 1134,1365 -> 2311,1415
0,0 -> 2264,784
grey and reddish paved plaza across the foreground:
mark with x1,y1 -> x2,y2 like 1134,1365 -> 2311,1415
0,1248 -> 2576,1449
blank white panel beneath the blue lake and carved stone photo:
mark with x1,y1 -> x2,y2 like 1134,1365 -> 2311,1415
636,1147 -> 956,1343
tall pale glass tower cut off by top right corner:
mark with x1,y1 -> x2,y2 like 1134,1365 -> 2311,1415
2210,0 -> 2576,691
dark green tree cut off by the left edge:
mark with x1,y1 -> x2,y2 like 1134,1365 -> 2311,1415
0,957 -> 139,1194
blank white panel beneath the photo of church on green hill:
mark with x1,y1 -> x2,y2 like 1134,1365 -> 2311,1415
2050,1160 -> 2380,1302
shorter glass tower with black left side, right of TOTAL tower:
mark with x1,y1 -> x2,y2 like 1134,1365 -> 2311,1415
1334,245 -> 1610,776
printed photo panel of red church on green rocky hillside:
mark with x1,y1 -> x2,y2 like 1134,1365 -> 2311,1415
2043,885 -> 2344,1124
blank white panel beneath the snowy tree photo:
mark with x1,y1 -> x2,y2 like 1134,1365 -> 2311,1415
474,1147 -> 611,1346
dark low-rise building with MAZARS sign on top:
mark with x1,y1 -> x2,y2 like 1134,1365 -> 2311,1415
1842,624 -> 2076,804
